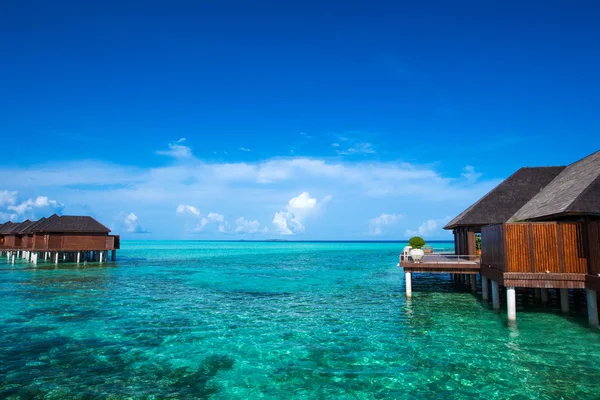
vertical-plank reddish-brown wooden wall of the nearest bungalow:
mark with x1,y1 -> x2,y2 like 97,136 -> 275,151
482,222 -> 587,274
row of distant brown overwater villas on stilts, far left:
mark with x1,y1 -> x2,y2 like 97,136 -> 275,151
0,214 -> 120,263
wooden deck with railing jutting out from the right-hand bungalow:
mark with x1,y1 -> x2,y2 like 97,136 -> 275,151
400,254 -> 480,275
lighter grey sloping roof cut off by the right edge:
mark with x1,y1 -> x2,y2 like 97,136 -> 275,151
512,151 -> 600,220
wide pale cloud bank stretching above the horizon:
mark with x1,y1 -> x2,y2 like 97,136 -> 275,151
0,134 -> 498,240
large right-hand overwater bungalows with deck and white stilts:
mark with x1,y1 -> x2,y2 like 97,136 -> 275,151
400,151 -> 600,327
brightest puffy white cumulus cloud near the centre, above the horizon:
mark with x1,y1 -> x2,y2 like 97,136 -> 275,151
272,192 -> 332,235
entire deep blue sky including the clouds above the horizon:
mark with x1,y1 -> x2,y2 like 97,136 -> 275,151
0,0 -> 600,240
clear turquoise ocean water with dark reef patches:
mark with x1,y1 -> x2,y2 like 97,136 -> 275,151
0,241 -> 600,399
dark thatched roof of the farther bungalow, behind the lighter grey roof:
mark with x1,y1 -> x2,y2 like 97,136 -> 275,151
444,167 -> 565,229
